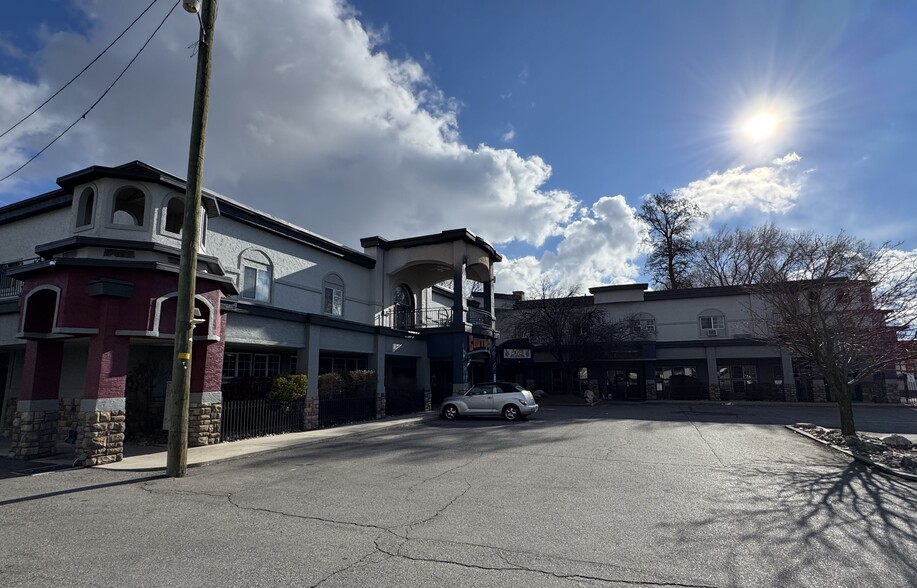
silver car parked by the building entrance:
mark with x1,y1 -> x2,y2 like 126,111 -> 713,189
440,382 -> 538,421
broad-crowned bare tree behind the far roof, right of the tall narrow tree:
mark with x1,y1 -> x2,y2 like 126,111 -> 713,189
691,223 -> 797,287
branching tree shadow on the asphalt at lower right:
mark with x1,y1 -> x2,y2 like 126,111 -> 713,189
661,462 -> 917,586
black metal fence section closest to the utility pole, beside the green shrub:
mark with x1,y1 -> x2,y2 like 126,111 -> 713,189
220,398 -> 305,441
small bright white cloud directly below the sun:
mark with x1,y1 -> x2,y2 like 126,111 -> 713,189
675,153 -> 806,220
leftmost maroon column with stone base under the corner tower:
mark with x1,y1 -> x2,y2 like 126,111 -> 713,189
9,340 -> 64,459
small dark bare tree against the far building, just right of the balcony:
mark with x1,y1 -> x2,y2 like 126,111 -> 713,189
509,279 -> 632,392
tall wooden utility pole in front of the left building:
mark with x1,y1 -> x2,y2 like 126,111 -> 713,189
166,0 -> 217,478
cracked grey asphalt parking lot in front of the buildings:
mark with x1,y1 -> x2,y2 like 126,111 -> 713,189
0,404 -> 917,587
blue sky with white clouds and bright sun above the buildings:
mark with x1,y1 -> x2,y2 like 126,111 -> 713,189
0,0 -> 917,292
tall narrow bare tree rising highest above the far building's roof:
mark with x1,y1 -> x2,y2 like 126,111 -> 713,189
637,192 -> 707,290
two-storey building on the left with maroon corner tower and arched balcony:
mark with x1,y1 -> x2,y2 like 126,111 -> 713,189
0,161 -> 501,465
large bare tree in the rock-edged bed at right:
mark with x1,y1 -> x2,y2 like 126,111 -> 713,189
751,233 -> 917,435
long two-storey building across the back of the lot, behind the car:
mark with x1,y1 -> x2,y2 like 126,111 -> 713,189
496,284 -> 899,402
